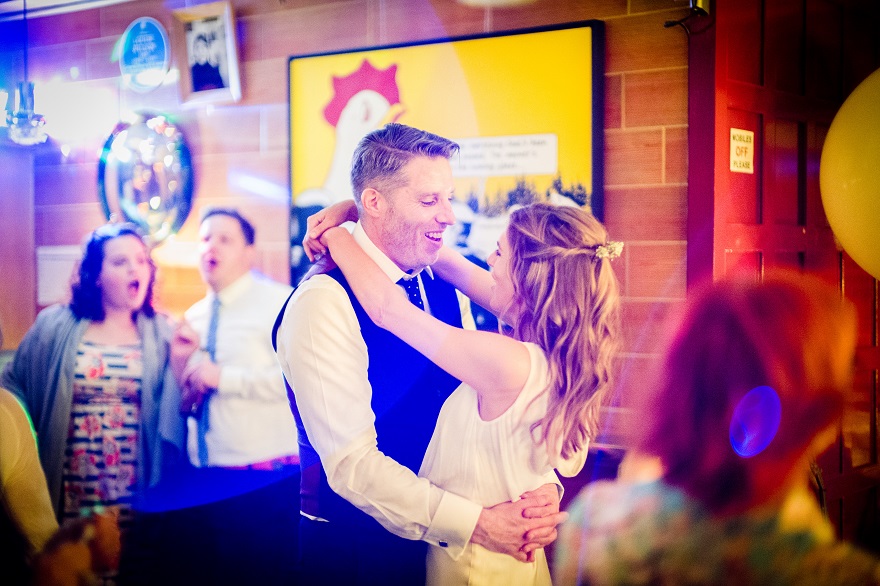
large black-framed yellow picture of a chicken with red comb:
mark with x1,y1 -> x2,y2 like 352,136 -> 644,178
289,21 -> 604,282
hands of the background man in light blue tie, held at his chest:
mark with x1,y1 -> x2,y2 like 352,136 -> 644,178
171,320 -> 220,417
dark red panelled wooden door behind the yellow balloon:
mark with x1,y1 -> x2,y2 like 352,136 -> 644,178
688,0 -> 880,551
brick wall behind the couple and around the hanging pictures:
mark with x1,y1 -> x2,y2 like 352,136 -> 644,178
0,0 -> 688,410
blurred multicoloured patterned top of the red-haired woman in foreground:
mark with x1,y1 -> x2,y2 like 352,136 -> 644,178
554,481 -> 880,586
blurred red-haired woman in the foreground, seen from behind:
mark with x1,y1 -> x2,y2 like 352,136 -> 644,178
555,272 -> 880,584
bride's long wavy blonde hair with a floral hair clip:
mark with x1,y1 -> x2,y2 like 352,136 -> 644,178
507,203 -> 620,458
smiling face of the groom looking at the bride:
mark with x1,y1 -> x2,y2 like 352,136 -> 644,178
377,157 -> 455,271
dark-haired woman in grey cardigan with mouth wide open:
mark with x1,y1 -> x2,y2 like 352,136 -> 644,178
0,224 -> 184,528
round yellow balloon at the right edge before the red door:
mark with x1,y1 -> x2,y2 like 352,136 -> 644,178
819,69 -> 880,279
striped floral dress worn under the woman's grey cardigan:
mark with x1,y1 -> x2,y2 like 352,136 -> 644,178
63,341 -> 143,529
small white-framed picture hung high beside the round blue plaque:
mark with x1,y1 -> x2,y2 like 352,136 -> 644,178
173,2 -> 241,104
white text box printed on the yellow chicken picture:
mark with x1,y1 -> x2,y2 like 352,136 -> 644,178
450,134 -> 559,177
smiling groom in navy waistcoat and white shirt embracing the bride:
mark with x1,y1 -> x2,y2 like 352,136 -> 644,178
275,124 -> 562,584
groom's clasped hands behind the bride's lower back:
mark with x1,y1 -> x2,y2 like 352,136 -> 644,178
471,484 -> 568,562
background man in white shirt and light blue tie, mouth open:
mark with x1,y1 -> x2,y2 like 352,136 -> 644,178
168,208 -> 299,584
